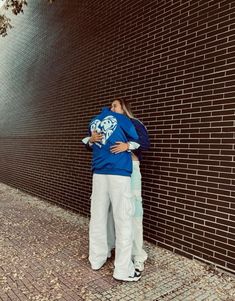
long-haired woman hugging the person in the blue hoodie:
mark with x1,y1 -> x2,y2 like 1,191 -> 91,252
85,98 -> 150,272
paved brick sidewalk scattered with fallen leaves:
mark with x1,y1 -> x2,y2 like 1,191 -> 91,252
0,184 -> 235,301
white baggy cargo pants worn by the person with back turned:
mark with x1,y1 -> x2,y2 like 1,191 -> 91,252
89,174 -> 135,280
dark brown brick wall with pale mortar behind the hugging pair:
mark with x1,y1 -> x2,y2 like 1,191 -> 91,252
0,0 -> 235,271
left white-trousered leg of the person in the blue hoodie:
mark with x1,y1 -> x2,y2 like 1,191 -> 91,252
89,174 -> 110,270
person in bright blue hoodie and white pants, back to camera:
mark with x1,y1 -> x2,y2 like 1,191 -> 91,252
83,108 -> 141,281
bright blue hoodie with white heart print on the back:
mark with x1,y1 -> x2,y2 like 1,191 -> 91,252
89,108 -> 138,176
